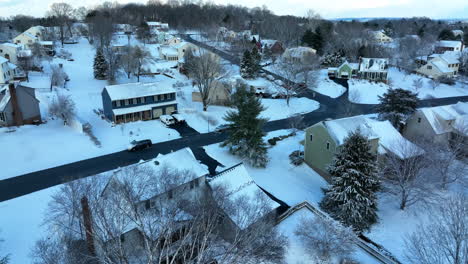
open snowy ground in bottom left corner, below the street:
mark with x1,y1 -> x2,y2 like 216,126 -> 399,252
0,186 -> 60,263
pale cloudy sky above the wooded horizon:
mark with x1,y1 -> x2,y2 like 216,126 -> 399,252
0,0 -> 468,19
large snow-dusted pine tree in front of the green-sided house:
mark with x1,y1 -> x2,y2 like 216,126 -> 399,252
320,130 -> 380,232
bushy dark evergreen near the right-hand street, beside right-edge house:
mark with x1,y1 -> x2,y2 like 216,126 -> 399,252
377,88 -> 419,131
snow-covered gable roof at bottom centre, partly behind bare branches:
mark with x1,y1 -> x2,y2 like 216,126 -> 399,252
208,163 -> 280,229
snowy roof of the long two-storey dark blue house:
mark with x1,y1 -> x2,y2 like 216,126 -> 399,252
105,79 -> 175,100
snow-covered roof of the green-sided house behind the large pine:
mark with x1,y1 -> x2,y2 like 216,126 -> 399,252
323,116 -> 417,158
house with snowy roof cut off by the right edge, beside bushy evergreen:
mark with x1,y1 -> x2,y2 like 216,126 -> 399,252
403,102 -> 468,143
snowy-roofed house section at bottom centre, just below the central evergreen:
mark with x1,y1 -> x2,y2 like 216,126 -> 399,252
207,163 -> 284,241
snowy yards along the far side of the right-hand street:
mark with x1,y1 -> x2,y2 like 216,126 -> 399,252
348,68 -> 468,104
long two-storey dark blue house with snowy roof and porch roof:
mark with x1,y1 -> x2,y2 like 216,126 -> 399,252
101,79 -> 177,124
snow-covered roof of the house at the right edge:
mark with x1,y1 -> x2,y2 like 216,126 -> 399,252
419,102 -> 468,134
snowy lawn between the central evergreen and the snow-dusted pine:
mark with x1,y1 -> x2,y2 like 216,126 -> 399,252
205,130 -> 327,206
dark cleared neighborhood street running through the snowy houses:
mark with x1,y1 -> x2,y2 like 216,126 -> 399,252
0,35 -> 468,202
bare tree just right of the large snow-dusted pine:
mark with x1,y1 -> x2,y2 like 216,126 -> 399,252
382,141 -> 435,210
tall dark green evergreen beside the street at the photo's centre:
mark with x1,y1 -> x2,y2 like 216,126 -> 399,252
222,83 -> 268,167
